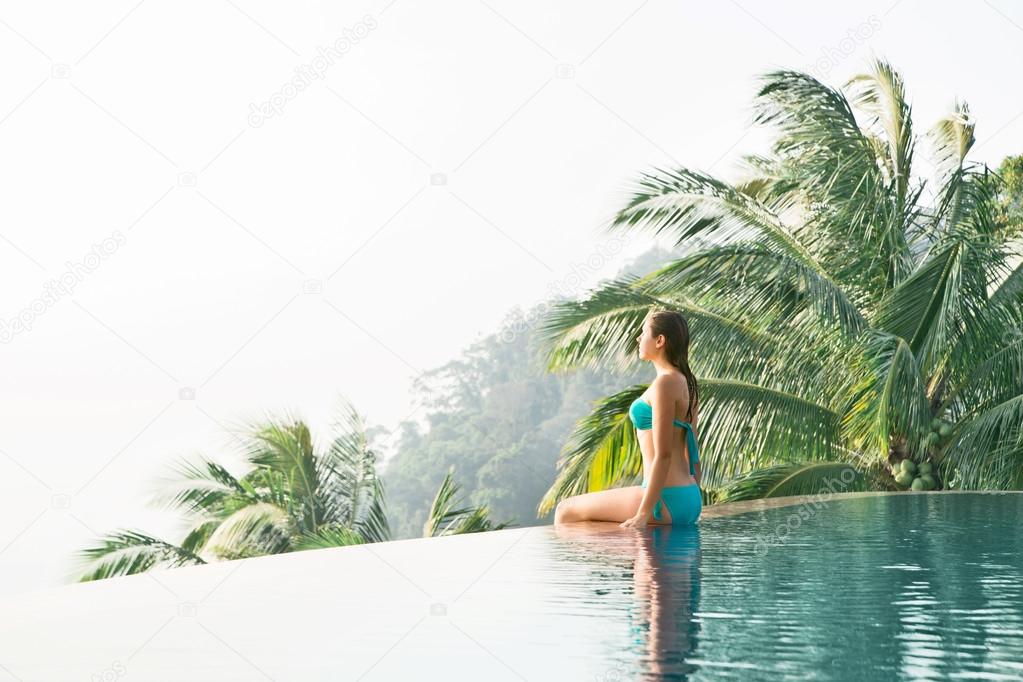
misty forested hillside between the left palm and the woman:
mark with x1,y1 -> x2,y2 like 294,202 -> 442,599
383,248 -> 672,539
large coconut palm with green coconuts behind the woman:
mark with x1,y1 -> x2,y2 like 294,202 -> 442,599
538,60 -> 1023,515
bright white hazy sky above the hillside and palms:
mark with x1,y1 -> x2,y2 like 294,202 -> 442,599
0,0 -> 1023,593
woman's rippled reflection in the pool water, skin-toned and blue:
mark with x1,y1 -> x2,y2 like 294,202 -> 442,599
630,526 -> 700,680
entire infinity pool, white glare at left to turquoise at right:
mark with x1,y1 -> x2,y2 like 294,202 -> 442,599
0,493 -> 1023,682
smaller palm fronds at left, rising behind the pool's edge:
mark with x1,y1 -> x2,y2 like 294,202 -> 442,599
79,394 -> 390,582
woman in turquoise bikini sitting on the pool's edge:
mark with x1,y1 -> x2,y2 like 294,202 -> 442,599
554,310 -> 703,528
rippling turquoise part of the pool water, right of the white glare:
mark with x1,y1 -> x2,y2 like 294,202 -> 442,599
561,493 -> 1023,681
